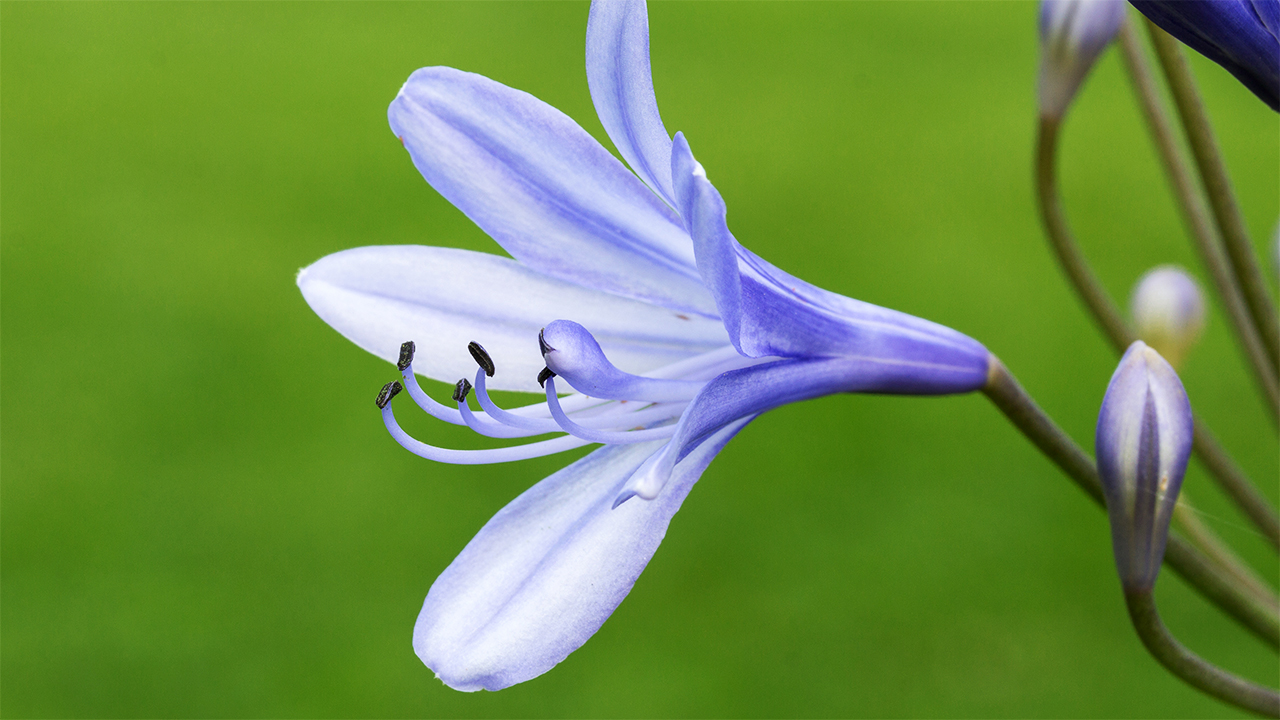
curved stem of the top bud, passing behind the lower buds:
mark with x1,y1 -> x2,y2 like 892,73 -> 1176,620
1036,118 -> 1280,547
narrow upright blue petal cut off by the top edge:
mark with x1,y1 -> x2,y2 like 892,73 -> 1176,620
586,0 -> 676,208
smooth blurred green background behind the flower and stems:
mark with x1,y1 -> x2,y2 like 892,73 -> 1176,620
0,1 -> 1280,717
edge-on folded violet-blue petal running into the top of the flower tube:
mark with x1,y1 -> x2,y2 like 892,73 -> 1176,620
672,133 -> 987,371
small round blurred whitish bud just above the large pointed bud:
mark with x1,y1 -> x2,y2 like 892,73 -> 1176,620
1129,265 -> 1204,368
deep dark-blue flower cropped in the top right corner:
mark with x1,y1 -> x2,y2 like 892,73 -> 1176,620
1130,0 -> 1280,111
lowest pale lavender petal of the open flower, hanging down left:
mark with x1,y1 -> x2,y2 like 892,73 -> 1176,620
413,418 -> 750,691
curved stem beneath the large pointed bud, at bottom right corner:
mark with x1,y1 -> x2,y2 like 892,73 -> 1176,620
1124,589 -> 1280,717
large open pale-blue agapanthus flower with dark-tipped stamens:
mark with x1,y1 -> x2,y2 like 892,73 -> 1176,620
298,0 -> 988,691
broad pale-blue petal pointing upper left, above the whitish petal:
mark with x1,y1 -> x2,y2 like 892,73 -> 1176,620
387,68 -> 716,316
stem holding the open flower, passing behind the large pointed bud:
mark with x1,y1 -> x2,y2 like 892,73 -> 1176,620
983,355 -> 1280,648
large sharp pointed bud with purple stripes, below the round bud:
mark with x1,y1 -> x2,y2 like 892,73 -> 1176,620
1096,341 -> 1192,591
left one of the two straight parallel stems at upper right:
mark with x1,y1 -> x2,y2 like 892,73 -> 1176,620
1120,19 -> 1276,409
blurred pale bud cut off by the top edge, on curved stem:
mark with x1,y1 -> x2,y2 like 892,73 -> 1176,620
1038,0 -> 1124,119
